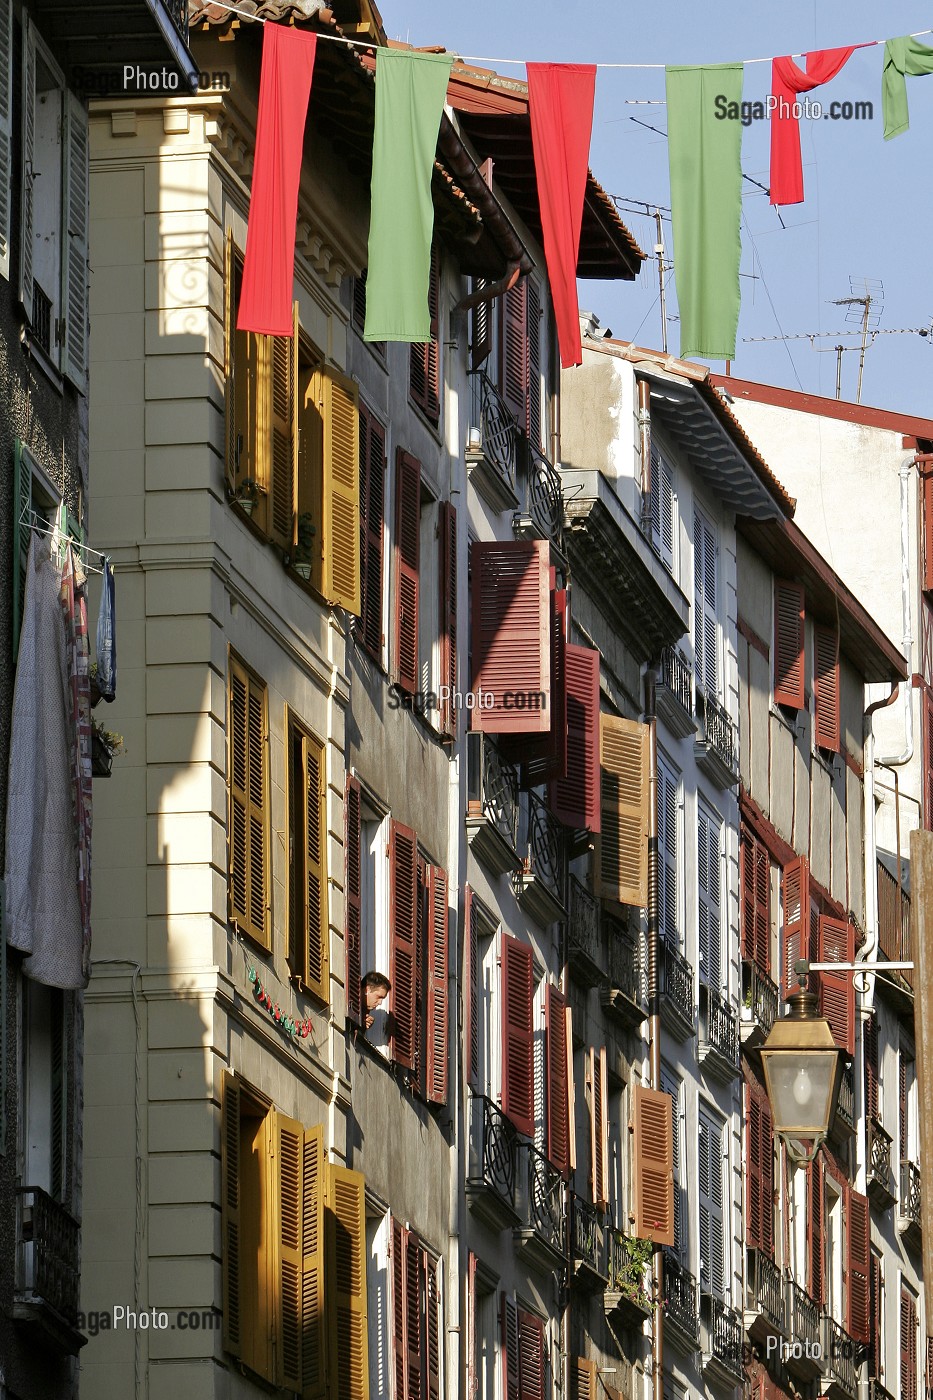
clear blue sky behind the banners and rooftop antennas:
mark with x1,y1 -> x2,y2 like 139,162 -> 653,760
381,0 -> 933,417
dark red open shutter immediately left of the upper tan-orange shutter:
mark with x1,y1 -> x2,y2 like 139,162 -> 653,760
548,643 -> 601,834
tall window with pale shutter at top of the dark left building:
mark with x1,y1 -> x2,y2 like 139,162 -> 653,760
19,15 -> 88,392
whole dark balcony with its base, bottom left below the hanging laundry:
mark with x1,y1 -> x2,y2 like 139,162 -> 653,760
13,1186 -> 87,1357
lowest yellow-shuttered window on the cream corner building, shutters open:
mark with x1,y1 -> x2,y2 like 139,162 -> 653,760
221,1074 -> 368,1394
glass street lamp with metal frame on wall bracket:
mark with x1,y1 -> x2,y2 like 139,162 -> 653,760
761,963 -> 843,1163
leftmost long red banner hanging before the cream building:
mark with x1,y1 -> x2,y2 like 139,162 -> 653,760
237,24 -> 318,336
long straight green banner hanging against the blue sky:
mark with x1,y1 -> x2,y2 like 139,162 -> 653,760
665,63 -> 742,360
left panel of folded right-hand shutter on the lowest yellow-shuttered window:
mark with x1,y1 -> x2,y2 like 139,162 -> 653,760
272,1112 -> 304,1390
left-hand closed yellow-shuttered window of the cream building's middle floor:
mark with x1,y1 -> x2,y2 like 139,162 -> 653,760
227,652 -> 272,948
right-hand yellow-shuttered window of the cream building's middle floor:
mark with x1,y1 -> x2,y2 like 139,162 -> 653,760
287,715 -> 331,1001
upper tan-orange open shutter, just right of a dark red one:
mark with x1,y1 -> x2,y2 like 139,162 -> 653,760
598,714 -> 649,909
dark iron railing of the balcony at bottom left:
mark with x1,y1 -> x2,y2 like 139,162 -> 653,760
17,1186 -> 81,1326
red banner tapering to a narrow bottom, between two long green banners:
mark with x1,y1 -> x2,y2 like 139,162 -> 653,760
525,63 -> 595,370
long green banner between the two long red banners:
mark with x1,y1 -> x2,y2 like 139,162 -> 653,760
363,49 -> 454,343
